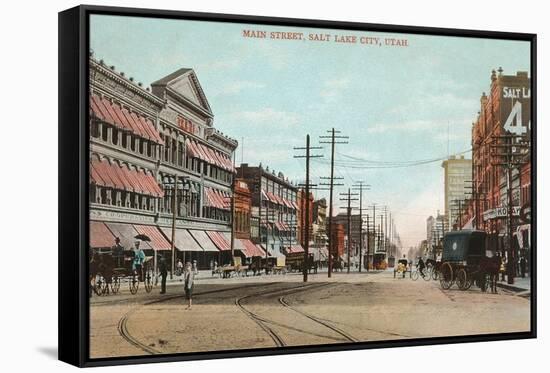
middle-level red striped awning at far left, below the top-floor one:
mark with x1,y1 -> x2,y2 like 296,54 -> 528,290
90,159 -> 164,198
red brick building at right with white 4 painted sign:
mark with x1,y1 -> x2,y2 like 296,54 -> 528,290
464,69 -> 531,251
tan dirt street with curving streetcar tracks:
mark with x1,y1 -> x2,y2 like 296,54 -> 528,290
90,271 -> 530,358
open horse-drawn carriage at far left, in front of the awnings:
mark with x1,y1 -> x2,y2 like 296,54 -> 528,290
90,246 -> 154,295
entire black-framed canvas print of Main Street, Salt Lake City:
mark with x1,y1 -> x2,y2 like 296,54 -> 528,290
59,6 -> 537,366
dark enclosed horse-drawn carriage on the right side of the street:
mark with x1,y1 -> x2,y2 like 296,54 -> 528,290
438,230 -> 500,292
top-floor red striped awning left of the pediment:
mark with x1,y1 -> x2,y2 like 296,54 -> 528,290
90,94 -> 164,144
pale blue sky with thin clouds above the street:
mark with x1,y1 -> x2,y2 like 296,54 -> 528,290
90,16 -> 530,246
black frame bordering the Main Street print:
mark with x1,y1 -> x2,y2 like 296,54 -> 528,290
58,5 -> 537,367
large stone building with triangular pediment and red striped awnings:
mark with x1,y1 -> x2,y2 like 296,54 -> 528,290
89,56 -> 268,267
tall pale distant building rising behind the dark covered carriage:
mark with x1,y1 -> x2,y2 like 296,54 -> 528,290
441,156 -> 472,231
